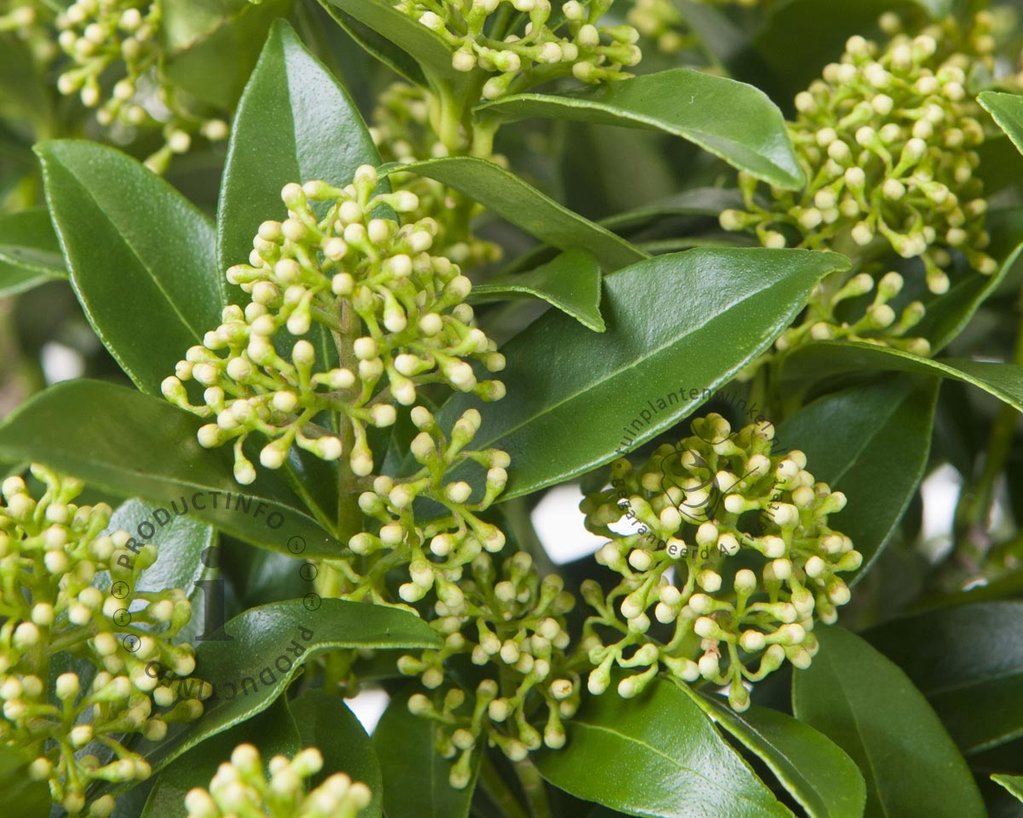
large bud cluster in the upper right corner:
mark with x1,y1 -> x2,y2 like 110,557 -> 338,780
720,13 -> 996,294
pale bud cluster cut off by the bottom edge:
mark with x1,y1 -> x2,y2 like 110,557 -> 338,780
185,744 -> 372,818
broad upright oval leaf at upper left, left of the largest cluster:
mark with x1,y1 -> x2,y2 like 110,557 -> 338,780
36,141 -> 225,395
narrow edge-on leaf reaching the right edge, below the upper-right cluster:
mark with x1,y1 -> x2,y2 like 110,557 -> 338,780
783,342 -> 1023,412
